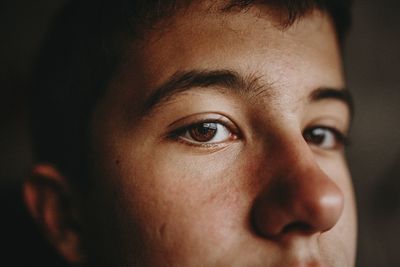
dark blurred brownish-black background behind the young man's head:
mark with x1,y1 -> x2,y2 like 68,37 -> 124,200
0,0 -> 400,267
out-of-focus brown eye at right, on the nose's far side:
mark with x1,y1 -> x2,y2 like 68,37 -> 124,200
303,126 -> 345,149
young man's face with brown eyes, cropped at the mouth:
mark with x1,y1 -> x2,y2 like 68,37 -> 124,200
87,4 -> 356,267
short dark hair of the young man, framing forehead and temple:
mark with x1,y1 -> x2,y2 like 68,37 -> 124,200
30,0 -> 351,188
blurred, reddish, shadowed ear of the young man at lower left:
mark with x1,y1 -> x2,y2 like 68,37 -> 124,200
23,164 -> 83,264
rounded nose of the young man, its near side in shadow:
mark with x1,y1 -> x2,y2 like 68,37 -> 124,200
252,143 -> 344,238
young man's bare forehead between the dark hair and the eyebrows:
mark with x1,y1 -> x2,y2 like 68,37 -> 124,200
110,6 -> 344,113
